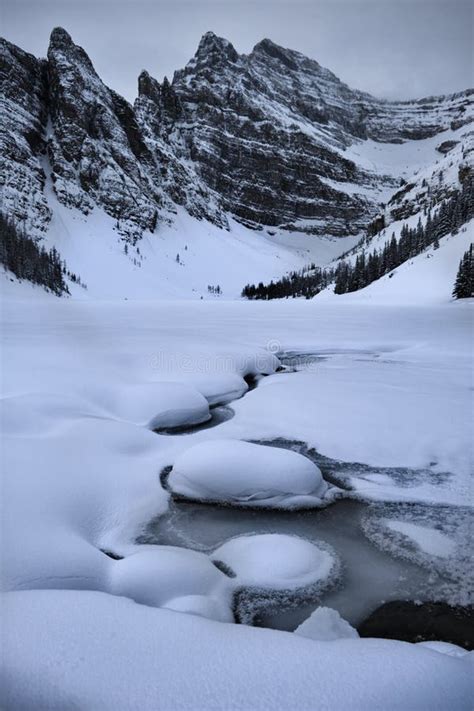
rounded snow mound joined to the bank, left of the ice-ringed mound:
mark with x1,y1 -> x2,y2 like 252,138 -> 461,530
110,546 -> 233,622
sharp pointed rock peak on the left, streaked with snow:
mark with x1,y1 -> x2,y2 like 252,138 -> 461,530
47,29 -> 162,239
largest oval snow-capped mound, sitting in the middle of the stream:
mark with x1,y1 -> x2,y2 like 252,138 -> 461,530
168,439 -> 328,509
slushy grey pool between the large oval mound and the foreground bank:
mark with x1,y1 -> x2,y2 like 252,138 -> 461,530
141,486 -> 456,630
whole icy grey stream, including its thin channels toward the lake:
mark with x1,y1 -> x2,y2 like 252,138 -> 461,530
139,351 -> 470,630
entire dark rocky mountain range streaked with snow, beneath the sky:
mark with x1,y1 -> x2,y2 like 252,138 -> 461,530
0,28 -> 474,241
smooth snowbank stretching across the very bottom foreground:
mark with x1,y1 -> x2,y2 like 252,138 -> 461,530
2,590 -> 472,711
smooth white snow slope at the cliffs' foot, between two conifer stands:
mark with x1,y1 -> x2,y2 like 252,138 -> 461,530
36,194 -> 357,299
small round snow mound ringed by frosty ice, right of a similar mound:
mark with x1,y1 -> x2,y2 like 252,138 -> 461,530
212,533 -> 335,590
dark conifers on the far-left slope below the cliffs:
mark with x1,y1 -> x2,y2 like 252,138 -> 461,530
0,213 -> 86,296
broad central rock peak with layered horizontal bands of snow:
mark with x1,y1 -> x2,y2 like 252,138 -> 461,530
168,33 -> 374,234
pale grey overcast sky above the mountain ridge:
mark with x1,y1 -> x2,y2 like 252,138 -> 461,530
0,0 -> 474,101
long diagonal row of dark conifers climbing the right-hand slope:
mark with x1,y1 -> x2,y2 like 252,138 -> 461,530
242,174 -> 474,299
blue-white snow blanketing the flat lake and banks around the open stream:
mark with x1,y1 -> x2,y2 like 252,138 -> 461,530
1,298 -> 471,711
